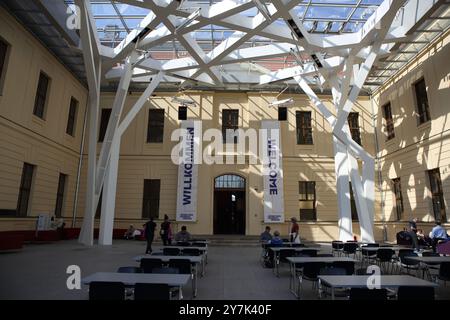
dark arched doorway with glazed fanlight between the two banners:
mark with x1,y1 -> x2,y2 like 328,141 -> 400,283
214,174 -> 245,234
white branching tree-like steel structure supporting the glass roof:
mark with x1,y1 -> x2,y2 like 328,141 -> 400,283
75,0 -> 445,245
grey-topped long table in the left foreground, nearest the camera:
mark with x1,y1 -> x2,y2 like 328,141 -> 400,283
81,272 -> 190,300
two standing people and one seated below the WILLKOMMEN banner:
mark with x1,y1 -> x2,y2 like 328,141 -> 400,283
144,215 -> 192,253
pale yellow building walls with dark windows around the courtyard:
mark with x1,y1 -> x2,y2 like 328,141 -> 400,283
0,9 -> 450,241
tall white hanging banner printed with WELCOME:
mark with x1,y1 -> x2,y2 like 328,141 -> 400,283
260,120 -> 284,223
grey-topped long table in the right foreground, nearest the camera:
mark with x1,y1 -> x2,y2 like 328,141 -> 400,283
319,275 -> 438,300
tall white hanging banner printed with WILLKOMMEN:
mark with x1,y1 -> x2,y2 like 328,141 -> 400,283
177,120 -> 202,221
